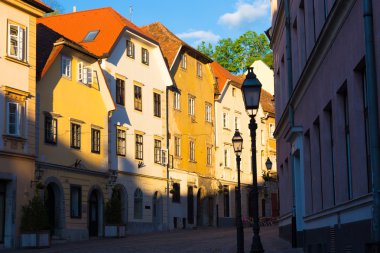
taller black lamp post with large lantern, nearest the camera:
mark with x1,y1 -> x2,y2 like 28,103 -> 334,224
241,67 -> 264,253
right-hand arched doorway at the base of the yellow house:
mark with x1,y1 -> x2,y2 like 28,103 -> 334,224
88,189 -> 103,237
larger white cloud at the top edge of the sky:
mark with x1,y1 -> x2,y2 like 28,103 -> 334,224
218,0 -> 270,28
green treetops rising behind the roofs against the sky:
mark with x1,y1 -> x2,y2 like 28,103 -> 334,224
197,31 -> 273,73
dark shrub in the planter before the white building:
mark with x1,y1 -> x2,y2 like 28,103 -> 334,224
104,187 -> 122,225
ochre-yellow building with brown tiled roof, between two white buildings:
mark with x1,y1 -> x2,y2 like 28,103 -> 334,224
142,22 -> 218,228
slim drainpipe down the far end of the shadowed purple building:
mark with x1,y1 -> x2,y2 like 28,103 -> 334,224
284,0 -> 297,248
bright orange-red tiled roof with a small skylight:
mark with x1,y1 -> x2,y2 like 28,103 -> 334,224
38,7 -> 158,57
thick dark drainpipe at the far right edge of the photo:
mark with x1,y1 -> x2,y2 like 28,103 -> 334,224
363,0 -> 380,249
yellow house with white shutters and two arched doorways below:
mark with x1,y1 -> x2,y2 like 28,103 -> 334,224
37,24 -> 115,240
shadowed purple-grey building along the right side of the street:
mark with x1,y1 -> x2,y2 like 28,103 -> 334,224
270,0 -> 380,252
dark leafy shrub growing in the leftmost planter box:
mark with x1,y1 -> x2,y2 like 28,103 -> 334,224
20,194 -> 50,232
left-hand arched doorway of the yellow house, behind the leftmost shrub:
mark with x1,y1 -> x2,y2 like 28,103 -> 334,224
44,180 -> 64,236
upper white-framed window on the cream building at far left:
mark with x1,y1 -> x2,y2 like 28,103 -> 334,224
8,24 -> 26,61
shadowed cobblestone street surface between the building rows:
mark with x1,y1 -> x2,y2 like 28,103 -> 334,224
8,226 -> 302,253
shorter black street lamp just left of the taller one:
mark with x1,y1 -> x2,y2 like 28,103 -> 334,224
232,129 -> 244,253
